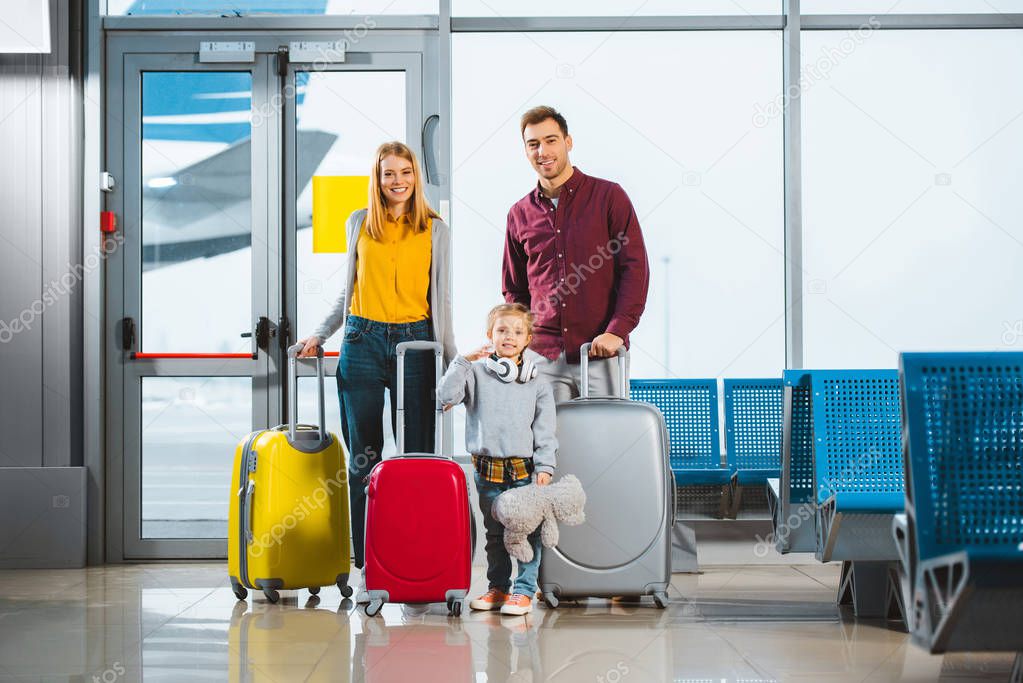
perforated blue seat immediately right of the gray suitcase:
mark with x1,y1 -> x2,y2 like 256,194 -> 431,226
629,379 -> 730,486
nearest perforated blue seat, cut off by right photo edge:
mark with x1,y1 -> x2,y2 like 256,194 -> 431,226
895,352 -> 1023,653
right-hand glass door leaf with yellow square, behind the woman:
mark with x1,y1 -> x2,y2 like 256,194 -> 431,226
284,52 -> 424,455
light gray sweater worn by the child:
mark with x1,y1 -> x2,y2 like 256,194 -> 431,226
437,356 -> 558,474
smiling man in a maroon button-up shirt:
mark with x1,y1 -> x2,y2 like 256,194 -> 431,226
501,106 -> 650,402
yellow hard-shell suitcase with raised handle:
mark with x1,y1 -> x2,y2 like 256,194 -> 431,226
227,345 -> 352,602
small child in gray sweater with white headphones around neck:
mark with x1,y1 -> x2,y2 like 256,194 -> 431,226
437,304 -> 558,616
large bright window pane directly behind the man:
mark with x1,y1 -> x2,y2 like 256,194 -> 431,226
452,31 -> 785,377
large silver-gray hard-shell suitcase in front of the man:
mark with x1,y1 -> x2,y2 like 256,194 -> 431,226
539,344 -> 675,608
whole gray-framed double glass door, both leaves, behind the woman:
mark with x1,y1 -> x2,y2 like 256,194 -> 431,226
105,35 -> 422,560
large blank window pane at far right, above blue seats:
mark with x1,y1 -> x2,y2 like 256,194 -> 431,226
803,31 -> 1023,367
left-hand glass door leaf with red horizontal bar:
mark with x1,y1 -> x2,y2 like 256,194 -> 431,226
107,50 -> 279,558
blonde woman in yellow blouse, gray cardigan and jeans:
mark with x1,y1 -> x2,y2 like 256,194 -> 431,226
300,142 -> 455,599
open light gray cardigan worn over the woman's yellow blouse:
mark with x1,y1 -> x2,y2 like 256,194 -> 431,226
313,209 -> 458,363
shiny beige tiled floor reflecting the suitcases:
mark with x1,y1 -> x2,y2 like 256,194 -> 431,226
0,563 -> 1013,683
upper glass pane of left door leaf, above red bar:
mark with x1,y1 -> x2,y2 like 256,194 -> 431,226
141,72 -> 252,353
